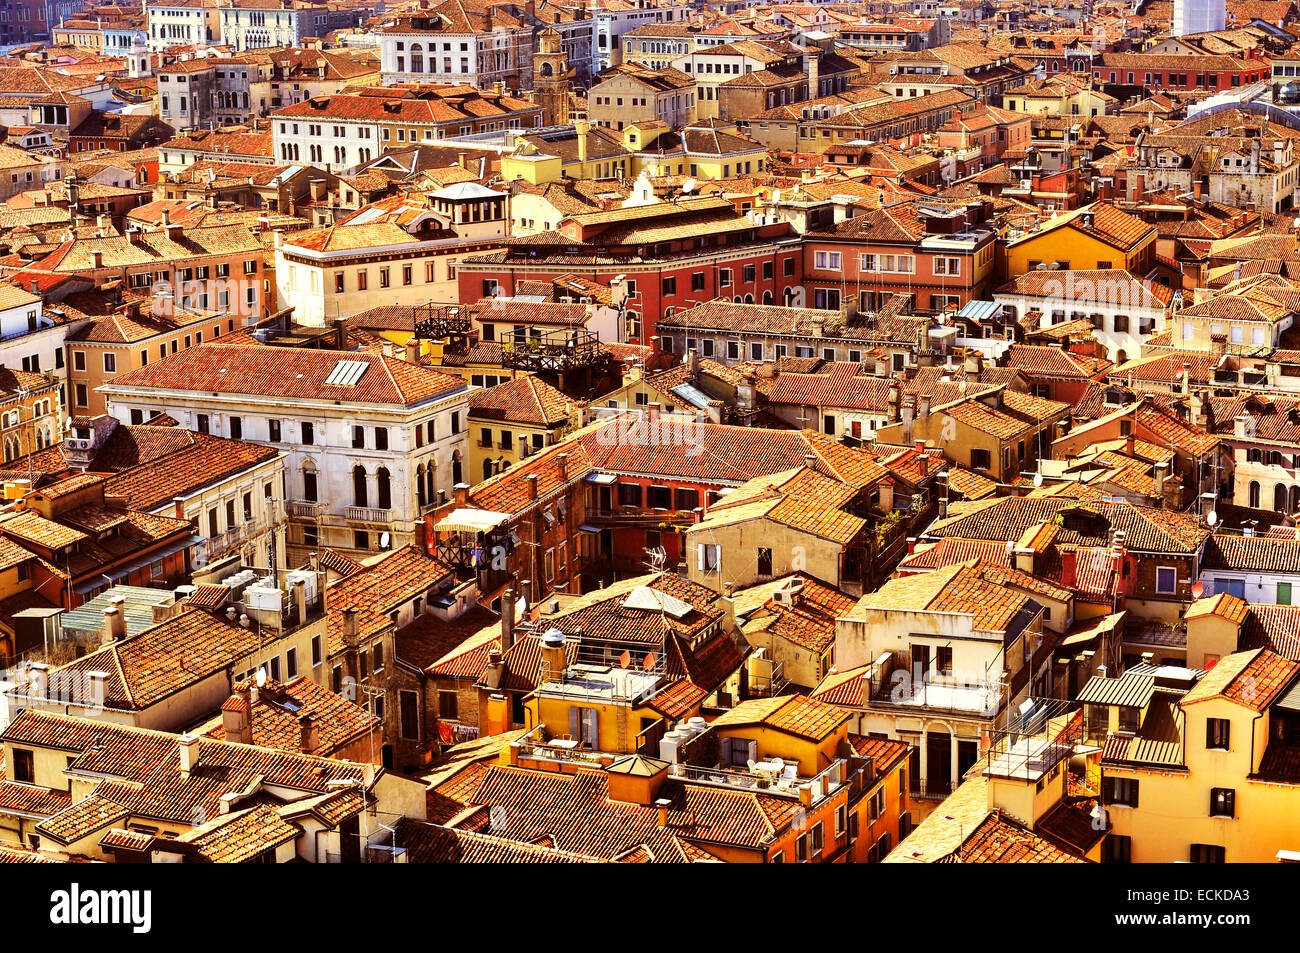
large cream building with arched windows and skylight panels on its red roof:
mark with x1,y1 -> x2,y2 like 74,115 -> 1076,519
103,345 -> 471,566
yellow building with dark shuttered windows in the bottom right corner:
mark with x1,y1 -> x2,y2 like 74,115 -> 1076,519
1080,649 -> 1300,863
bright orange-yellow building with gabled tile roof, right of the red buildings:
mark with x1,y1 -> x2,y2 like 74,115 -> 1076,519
1005,203 -> 1156,278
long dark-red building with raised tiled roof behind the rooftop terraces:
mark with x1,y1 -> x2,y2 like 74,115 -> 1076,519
456,196 -> 803,345
